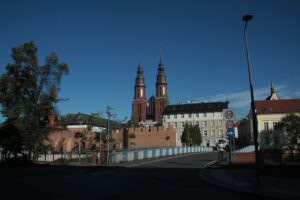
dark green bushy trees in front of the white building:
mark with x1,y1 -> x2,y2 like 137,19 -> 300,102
181,123 -> 202,146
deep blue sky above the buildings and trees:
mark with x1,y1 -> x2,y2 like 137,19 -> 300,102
0,0 -> 300,119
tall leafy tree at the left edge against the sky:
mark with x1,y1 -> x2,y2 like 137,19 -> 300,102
0,41 -> 68,159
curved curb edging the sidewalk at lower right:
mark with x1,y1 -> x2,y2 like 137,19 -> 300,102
198,160 -> 299,200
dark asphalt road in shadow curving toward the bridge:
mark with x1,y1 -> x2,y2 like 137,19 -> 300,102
0,153 -> 270,200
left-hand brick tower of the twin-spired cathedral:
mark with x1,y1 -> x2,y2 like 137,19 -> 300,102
132,64 -> 147,122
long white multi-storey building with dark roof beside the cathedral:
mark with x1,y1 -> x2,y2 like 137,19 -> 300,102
163,102 -> 228,146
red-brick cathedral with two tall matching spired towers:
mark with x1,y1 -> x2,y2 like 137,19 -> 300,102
132,57 -> 169,122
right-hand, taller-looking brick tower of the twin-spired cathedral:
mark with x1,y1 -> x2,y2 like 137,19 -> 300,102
153,56 -> 169,122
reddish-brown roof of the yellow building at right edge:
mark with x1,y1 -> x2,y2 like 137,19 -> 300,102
255,99 -> 300,114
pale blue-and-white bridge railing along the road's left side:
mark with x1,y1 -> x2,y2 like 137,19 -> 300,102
108,146 -> 213,164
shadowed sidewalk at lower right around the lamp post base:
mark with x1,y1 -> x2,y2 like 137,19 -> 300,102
199,161 -> 300,200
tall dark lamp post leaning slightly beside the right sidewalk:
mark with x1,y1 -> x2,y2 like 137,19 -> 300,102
243,15 -> 260,188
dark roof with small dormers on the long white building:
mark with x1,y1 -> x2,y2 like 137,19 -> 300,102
163,101 -> 228,115
